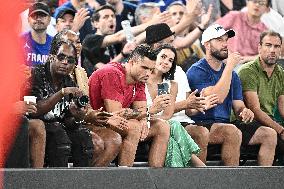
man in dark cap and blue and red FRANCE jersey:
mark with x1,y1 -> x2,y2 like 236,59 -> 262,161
21,2 -> 52,66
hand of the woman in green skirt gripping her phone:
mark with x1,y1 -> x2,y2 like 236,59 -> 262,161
149,94 -> 171,114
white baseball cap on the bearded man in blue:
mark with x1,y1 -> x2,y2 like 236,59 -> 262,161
201,24 -> 235,45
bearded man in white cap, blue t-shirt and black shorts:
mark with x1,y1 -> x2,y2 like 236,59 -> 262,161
187,24 -> 277,166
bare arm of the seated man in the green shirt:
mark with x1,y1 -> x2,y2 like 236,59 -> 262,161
244,91 -> 283,134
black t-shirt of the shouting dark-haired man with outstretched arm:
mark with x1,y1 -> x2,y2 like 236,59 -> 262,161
82,34 -> 121,76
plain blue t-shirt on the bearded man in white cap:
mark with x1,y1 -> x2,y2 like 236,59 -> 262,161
186,58 -> 243,123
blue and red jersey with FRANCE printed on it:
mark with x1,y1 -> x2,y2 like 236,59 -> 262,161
21,32 -> 52,66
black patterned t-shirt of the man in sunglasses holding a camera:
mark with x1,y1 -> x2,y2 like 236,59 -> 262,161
31,62 -> 76,122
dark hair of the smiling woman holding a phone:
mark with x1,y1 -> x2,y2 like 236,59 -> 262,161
156,44 -> 177,80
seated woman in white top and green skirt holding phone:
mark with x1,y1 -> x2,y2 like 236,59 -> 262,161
146,44 -> 205,167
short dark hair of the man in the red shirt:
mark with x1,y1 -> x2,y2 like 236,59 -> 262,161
128,44 -> 157,63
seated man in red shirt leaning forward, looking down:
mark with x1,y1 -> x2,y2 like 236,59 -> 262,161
89,45 -> 170,167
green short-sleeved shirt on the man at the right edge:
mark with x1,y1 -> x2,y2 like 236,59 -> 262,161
238,58 -> 284,118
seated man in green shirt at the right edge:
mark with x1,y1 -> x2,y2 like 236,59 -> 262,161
239,31 -> 284,162
